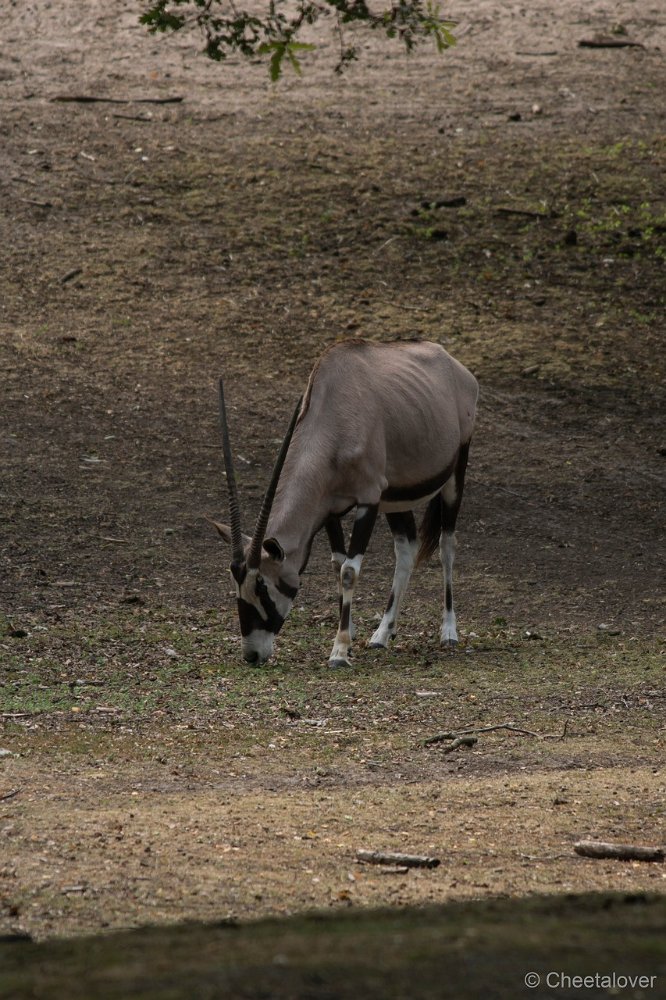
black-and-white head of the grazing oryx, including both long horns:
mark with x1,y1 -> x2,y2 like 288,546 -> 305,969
211,379 -> 301,663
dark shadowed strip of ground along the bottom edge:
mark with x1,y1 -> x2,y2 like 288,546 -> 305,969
0,894 -> 666,1000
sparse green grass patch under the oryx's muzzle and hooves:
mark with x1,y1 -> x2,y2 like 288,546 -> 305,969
0,608 -> 665,764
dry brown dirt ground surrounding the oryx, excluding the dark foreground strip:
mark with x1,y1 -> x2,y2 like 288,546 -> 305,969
0,0 -> 666,971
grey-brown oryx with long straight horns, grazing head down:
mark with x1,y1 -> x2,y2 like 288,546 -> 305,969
213,340 -> 478,667
